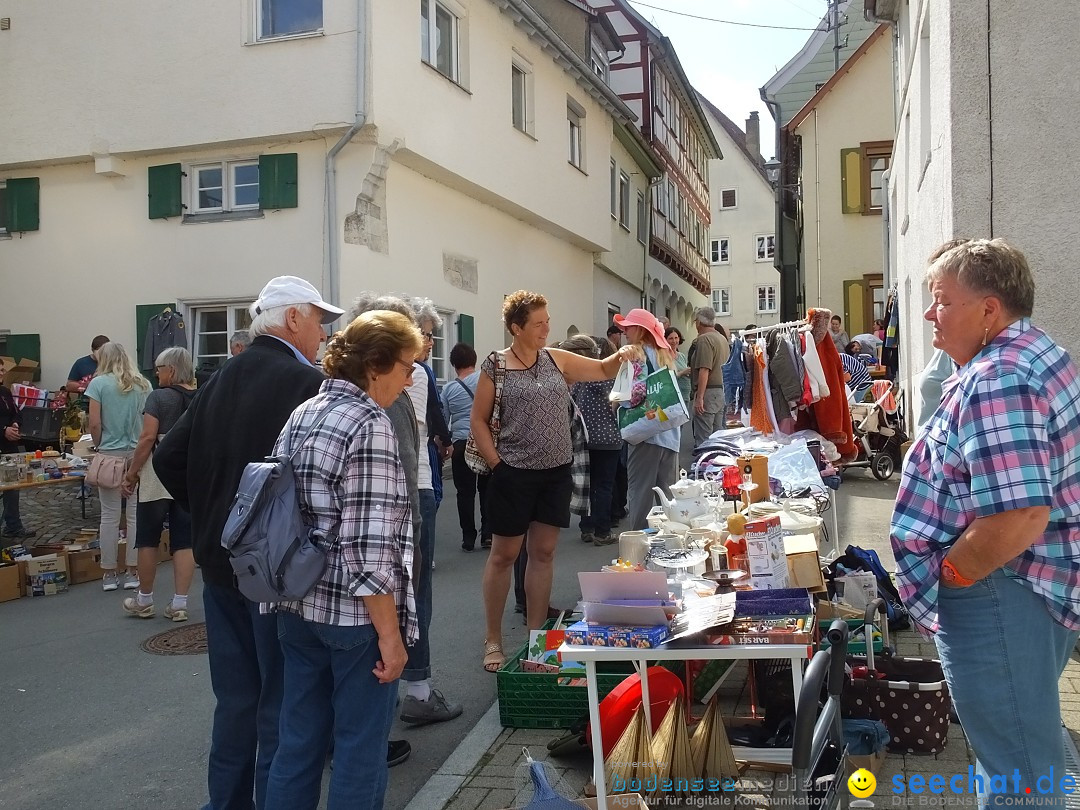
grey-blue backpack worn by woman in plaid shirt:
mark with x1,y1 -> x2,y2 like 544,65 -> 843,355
221,402 -> 340,602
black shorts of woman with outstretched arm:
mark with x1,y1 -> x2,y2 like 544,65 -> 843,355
487,461 -> 573,537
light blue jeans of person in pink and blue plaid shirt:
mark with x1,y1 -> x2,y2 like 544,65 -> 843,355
934,570 -> 1078,807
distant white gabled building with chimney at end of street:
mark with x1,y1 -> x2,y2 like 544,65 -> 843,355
698,94 -> 780,332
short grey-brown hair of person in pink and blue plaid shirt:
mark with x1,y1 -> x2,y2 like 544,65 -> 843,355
927,239 -> 1035,318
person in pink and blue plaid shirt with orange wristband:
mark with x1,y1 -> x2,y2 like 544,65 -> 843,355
886,239 -> 1080,807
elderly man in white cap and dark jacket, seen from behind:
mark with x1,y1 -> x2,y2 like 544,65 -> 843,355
153,275 -> 345,810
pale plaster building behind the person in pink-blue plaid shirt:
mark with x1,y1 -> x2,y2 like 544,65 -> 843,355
864,0 -> 1080,408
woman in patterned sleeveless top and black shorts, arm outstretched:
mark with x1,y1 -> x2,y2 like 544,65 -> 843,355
470,289 -> 639,672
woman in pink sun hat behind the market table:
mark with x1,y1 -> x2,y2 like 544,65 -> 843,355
615,309 -> 679,529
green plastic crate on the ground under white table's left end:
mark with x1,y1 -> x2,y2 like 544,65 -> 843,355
496,644 -> 634,728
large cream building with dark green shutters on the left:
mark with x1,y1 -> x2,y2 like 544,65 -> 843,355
0,0 -> 644,388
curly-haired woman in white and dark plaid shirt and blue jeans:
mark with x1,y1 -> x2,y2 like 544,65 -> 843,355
264,310 -> 422,810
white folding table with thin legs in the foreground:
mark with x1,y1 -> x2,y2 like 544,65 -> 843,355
558,640 -> 813,810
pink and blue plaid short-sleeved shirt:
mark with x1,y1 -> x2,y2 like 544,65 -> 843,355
890,318 -> 1080,633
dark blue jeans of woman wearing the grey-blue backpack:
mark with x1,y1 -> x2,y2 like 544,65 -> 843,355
266,612 -> 397,810
